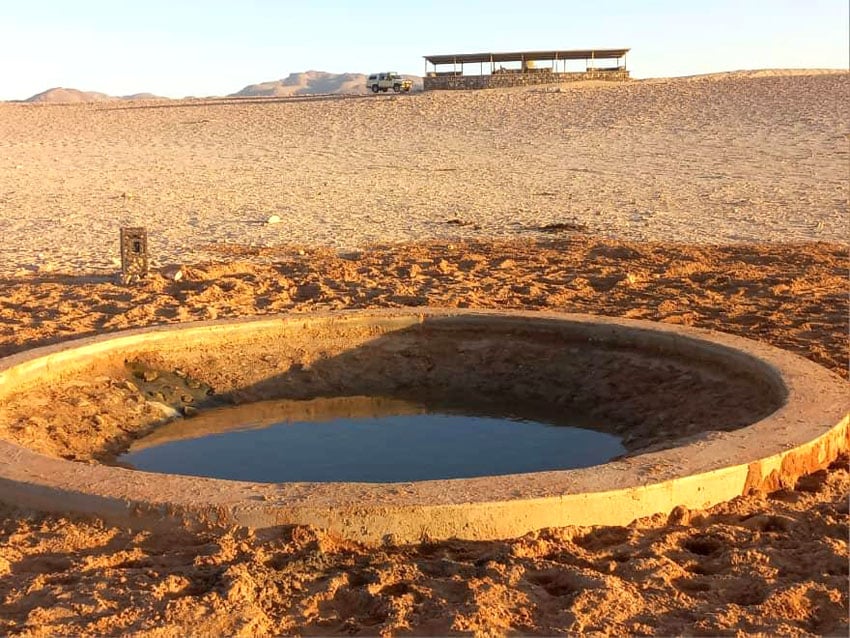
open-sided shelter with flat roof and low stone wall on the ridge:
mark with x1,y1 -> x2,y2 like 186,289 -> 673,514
424,49 -> 629,91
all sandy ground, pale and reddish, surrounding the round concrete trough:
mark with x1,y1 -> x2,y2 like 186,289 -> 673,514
0,74 -> 850,636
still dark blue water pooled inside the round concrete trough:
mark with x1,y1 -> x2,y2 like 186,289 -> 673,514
119,400 -> 625,483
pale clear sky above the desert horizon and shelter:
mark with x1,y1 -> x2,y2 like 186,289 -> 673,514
0,0 -> 850,100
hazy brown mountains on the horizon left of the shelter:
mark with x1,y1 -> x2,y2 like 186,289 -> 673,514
24,71 -> 422,104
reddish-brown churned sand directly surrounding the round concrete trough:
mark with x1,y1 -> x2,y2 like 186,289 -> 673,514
0,234 -> 850,636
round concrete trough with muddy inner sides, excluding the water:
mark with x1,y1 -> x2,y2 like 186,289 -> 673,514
0,309 -> 848,543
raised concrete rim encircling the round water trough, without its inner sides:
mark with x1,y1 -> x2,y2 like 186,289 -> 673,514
0,308 -> 850,543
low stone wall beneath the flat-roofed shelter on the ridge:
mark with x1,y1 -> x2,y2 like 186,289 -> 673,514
424,67 -> 629,91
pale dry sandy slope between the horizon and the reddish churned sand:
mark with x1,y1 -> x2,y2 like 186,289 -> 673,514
0,73 -> 850,273
